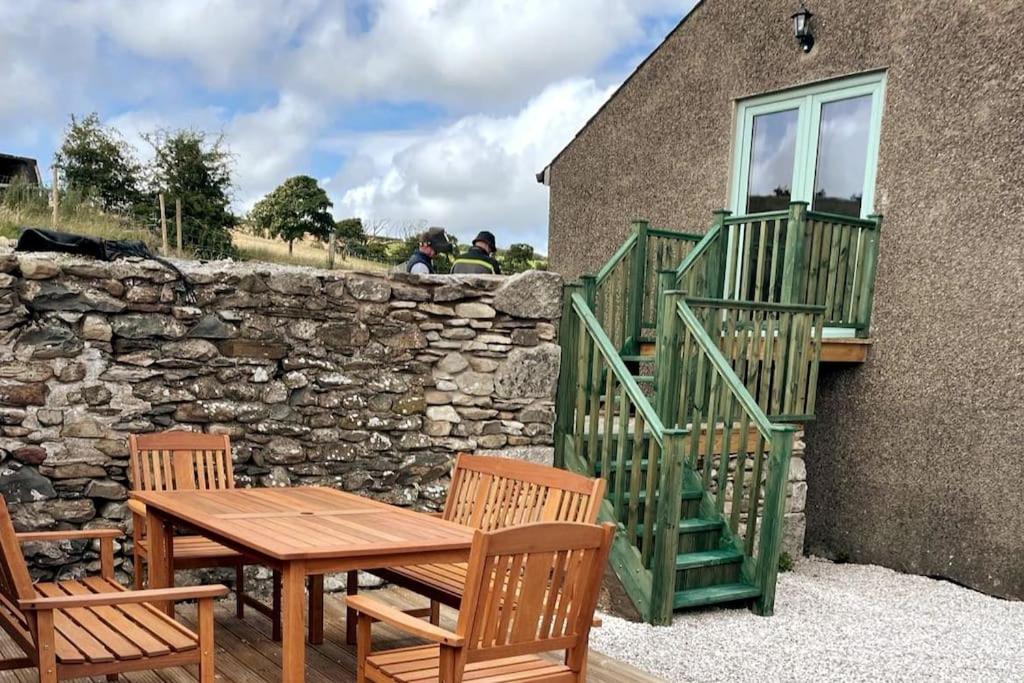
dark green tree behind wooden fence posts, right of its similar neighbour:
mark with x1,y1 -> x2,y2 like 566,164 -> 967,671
143,130 -> 239,258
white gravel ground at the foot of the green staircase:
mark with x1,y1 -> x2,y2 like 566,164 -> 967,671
591,558 -> 1024,682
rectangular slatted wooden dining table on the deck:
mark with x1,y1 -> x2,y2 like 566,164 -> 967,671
132,487 -> 473,682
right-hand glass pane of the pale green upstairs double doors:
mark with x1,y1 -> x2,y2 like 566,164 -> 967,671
813,95 -> 871,216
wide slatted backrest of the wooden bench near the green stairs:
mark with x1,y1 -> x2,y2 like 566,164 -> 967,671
443,454 -> 605,531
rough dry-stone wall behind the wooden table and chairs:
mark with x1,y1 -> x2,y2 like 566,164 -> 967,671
0,252 -> 561,575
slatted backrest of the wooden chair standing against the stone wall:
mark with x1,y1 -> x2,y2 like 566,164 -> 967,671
128,430 -> 234,490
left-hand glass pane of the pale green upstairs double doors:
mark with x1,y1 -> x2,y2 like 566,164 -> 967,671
746,110 -> 799,213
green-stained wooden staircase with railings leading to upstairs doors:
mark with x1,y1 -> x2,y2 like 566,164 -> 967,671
555,203 -> 881,624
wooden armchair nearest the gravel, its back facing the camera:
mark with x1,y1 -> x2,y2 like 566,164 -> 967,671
348,522 -> 615,683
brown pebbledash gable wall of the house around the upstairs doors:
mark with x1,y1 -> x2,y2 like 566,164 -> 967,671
549,0 -> 1024,598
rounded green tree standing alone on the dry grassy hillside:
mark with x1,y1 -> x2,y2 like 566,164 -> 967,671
249,175 -> 335,254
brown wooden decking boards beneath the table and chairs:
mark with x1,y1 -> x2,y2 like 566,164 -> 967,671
0,588 -> 660,683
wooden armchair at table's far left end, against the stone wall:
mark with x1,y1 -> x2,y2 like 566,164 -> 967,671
128,430 -> 324,642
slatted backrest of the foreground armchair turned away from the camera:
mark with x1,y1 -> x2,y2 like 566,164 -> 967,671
457,522 -> 615,671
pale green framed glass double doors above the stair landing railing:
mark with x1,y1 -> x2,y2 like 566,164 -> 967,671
731,74 -> 886,217
